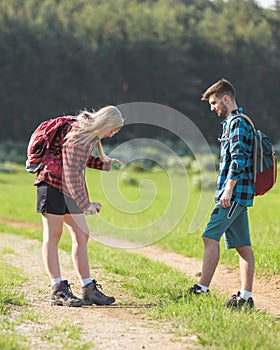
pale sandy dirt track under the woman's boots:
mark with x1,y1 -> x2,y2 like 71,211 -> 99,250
0,233 -> 197,350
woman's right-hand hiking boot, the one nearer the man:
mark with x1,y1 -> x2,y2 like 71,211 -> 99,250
82,280 -> 115,305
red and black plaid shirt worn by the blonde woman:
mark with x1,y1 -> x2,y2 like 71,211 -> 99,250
34,124 -> 111,211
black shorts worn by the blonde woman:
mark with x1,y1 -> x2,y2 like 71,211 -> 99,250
37,182 -> 83,215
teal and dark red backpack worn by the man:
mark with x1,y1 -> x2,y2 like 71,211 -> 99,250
225,113 -> 277,196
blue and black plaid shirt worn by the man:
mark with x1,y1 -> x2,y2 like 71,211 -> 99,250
216,108 -> 254,207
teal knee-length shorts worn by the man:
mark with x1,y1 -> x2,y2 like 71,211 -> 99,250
202,202 -> 251,249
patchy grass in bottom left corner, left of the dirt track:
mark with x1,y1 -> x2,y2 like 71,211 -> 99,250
0,243 -> 93,350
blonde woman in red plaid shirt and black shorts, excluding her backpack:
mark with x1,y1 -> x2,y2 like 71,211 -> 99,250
34,106 -> 124,306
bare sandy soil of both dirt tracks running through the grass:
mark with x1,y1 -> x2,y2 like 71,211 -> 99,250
0,223 -> 280,350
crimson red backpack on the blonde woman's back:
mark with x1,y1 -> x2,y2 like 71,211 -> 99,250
25,116 -> 77,174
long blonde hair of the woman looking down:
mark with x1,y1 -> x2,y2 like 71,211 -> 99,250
66,106 -> 124,162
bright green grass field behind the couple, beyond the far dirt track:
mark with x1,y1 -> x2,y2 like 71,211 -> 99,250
0,165 -> 280,274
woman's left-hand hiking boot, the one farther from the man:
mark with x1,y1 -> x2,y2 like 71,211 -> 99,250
51,280 -> 83,307
